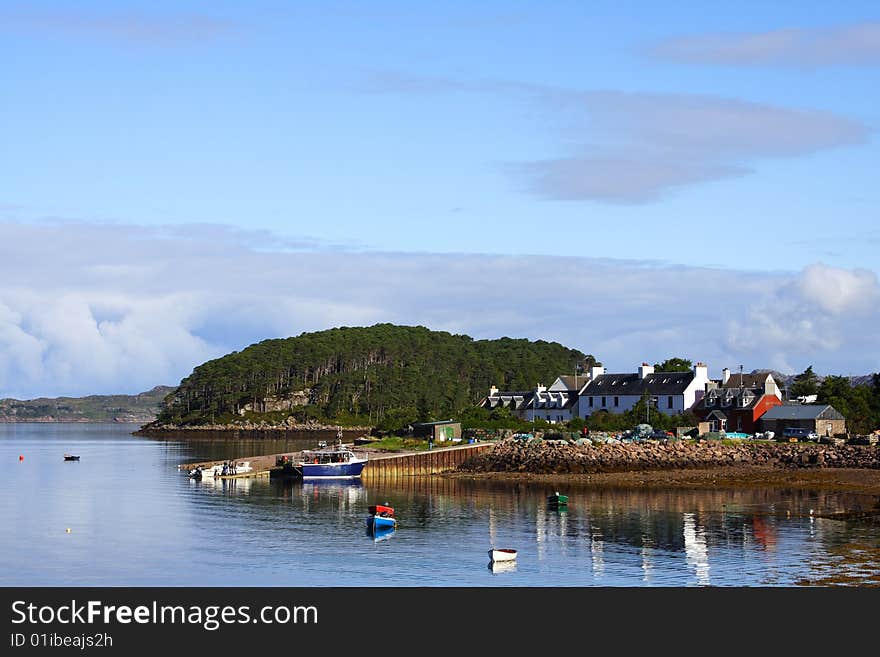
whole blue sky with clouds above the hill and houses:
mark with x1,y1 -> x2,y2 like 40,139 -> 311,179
0,0 -> 880,396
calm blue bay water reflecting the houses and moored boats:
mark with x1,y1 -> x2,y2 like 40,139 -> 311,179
0,424 -> 880,587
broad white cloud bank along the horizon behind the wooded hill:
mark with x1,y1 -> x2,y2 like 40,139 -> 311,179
0,224 -> 880,398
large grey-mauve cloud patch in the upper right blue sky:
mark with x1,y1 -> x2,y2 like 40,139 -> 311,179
368,72 -> 870,204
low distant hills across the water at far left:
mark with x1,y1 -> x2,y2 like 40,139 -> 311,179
0,386 -> 174,424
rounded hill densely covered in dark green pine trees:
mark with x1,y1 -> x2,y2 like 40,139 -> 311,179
158,324 -> 585,426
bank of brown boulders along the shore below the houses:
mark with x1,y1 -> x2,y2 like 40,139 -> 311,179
458,440 -> 880,475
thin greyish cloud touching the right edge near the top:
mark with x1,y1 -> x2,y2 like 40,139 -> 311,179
649,22 -> 880,68
